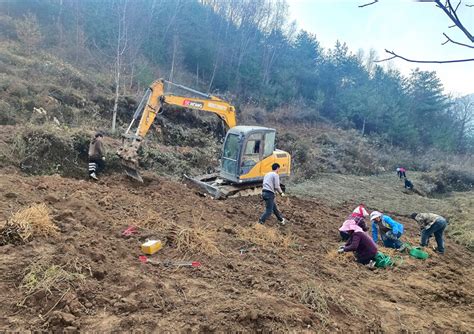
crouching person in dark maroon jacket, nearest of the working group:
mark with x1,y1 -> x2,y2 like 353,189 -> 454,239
338,220 -> 377,264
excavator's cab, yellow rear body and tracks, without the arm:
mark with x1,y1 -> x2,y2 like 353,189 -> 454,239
185,126 -> 291,199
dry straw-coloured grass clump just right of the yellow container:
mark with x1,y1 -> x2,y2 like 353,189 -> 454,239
169,225 -> 221,255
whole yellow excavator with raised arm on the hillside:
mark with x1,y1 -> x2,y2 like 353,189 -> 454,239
117,79 -> 291,199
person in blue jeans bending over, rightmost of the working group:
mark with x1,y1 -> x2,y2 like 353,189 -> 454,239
410,212 -> 448,254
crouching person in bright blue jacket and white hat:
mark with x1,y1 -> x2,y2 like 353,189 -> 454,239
370,211 -> 405,251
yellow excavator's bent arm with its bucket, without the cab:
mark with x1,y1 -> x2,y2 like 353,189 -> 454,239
117,79 -> 237,182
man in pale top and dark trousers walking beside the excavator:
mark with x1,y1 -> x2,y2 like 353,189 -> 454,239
258,163 -> 286,225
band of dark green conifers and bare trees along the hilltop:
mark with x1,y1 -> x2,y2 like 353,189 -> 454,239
2,0 -> 474,153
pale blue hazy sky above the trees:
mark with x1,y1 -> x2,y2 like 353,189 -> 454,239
288,0 -> 474,94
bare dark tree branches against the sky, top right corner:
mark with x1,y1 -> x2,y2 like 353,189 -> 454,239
359,0 -> 474,64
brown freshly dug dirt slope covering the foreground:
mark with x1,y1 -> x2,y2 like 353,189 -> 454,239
0,171 -> 474,333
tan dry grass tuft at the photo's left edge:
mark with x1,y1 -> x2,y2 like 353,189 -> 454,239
0,203 -> 59,244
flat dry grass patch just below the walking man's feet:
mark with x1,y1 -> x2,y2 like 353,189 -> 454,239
238,224 -> 295,249
